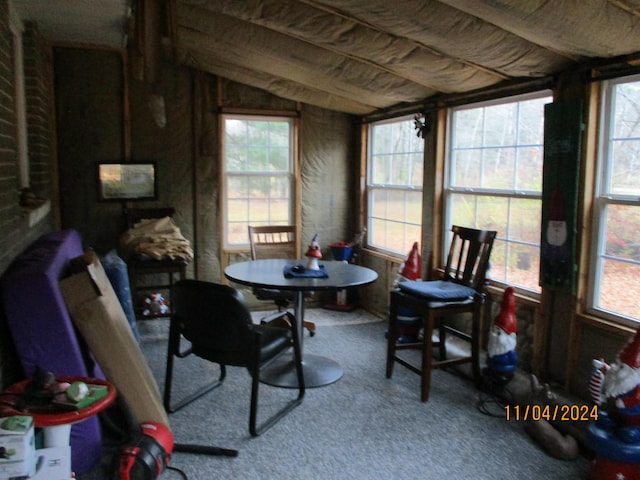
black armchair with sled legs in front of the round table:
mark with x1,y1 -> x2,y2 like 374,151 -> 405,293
164,280 -> 305,436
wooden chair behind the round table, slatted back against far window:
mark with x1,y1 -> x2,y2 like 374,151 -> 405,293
249,225 -> 316,336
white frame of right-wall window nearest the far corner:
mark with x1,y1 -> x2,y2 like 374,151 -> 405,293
365,115 -> 426,258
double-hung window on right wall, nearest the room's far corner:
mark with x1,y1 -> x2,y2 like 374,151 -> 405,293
367,118 -> 424,255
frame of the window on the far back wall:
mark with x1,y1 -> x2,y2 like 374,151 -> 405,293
219,113 -> 298,252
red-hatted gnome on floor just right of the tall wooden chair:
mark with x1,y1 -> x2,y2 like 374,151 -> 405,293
485,287 -> 518,385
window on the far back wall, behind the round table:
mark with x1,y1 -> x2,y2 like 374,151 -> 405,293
223,115 -> 294,248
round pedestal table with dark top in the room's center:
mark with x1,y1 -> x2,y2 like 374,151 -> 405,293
224,259 -> 378,388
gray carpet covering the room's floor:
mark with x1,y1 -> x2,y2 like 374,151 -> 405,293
78,309 -> 589,480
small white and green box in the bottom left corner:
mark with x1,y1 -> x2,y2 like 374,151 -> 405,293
0,415 -> 35,480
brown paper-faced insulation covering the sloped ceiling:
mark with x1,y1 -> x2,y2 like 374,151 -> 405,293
12,0 -> 640,115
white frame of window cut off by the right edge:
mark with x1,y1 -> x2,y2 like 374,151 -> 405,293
585,74 -> 640,329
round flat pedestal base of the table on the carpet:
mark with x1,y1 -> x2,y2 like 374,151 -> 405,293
260,354 -> 344,388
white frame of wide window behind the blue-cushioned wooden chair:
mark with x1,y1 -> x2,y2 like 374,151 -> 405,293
440,89 -> 553,292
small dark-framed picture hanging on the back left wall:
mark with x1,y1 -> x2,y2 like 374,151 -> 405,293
98,162 -> 157,201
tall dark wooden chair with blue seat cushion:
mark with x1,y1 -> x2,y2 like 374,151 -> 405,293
386,225 -> 497,402
